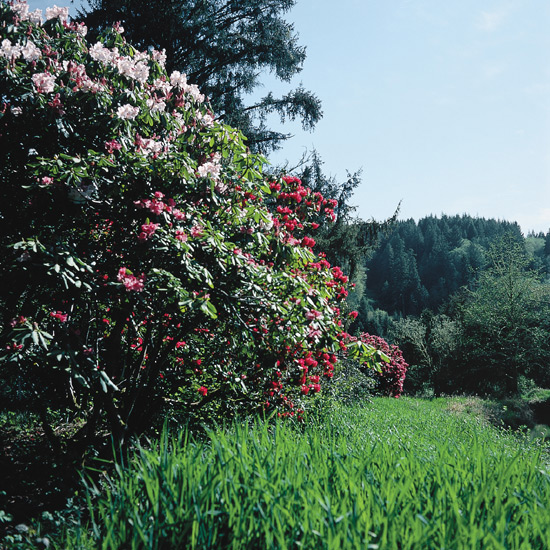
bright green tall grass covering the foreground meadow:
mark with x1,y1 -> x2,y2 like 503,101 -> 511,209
70,399 -> 550,550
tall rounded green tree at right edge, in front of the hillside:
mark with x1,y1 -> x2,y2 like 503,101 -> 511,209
461,236 -> 550,395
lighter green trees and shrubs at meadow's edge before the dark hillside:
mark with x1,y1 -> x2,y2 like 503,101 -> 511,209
390,234 -> 550,396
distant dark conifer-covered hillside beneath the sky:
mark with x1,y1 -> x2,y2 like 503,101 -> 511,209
360,215 -> 550,329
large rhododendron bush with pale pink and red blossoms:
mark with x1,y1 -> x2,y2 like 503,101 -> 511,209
0,2 -> 377,442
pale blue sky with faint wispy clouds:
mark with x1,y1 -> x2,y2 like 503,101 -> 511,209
29,0 -> 550,233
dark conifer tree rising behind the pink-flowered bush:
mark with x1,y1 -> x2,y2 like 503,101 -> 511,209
75,0 -> 322,153
